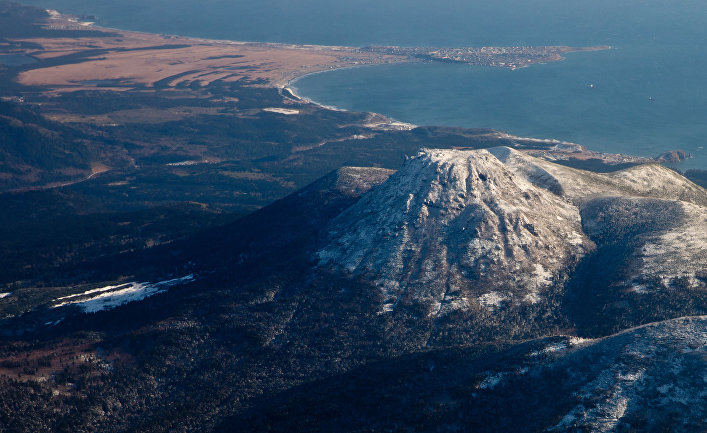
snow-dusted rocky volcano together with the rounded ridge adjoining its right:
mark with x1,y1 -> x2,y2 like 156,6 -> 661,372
317,147 -> 707,315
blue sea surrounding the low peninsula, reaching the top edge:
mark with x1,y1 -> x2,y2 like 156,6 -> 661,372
21,0 -> 707,169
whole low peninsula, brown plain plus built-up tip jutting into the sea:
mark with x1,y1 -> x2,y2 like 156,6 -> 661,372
5,10 -> 610,92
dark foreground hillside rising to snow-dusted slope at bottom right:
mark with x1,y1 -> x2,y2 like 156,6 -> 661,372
236,316 -> 707,432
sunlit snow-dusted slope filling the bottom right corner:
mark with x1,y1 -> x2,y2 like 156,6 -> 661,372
547,316 -> 707,432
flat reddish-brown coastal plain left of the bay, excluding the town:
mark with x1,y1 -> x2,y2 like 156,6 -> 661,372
13,14 -> 410,92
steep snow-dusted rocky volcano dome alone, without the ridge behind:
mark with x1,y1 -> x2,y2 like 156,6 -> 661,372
318,148 -> 592,313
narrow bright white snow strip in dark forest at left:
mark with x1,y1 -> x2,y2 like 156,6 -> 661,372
52,274 -> 195,313
